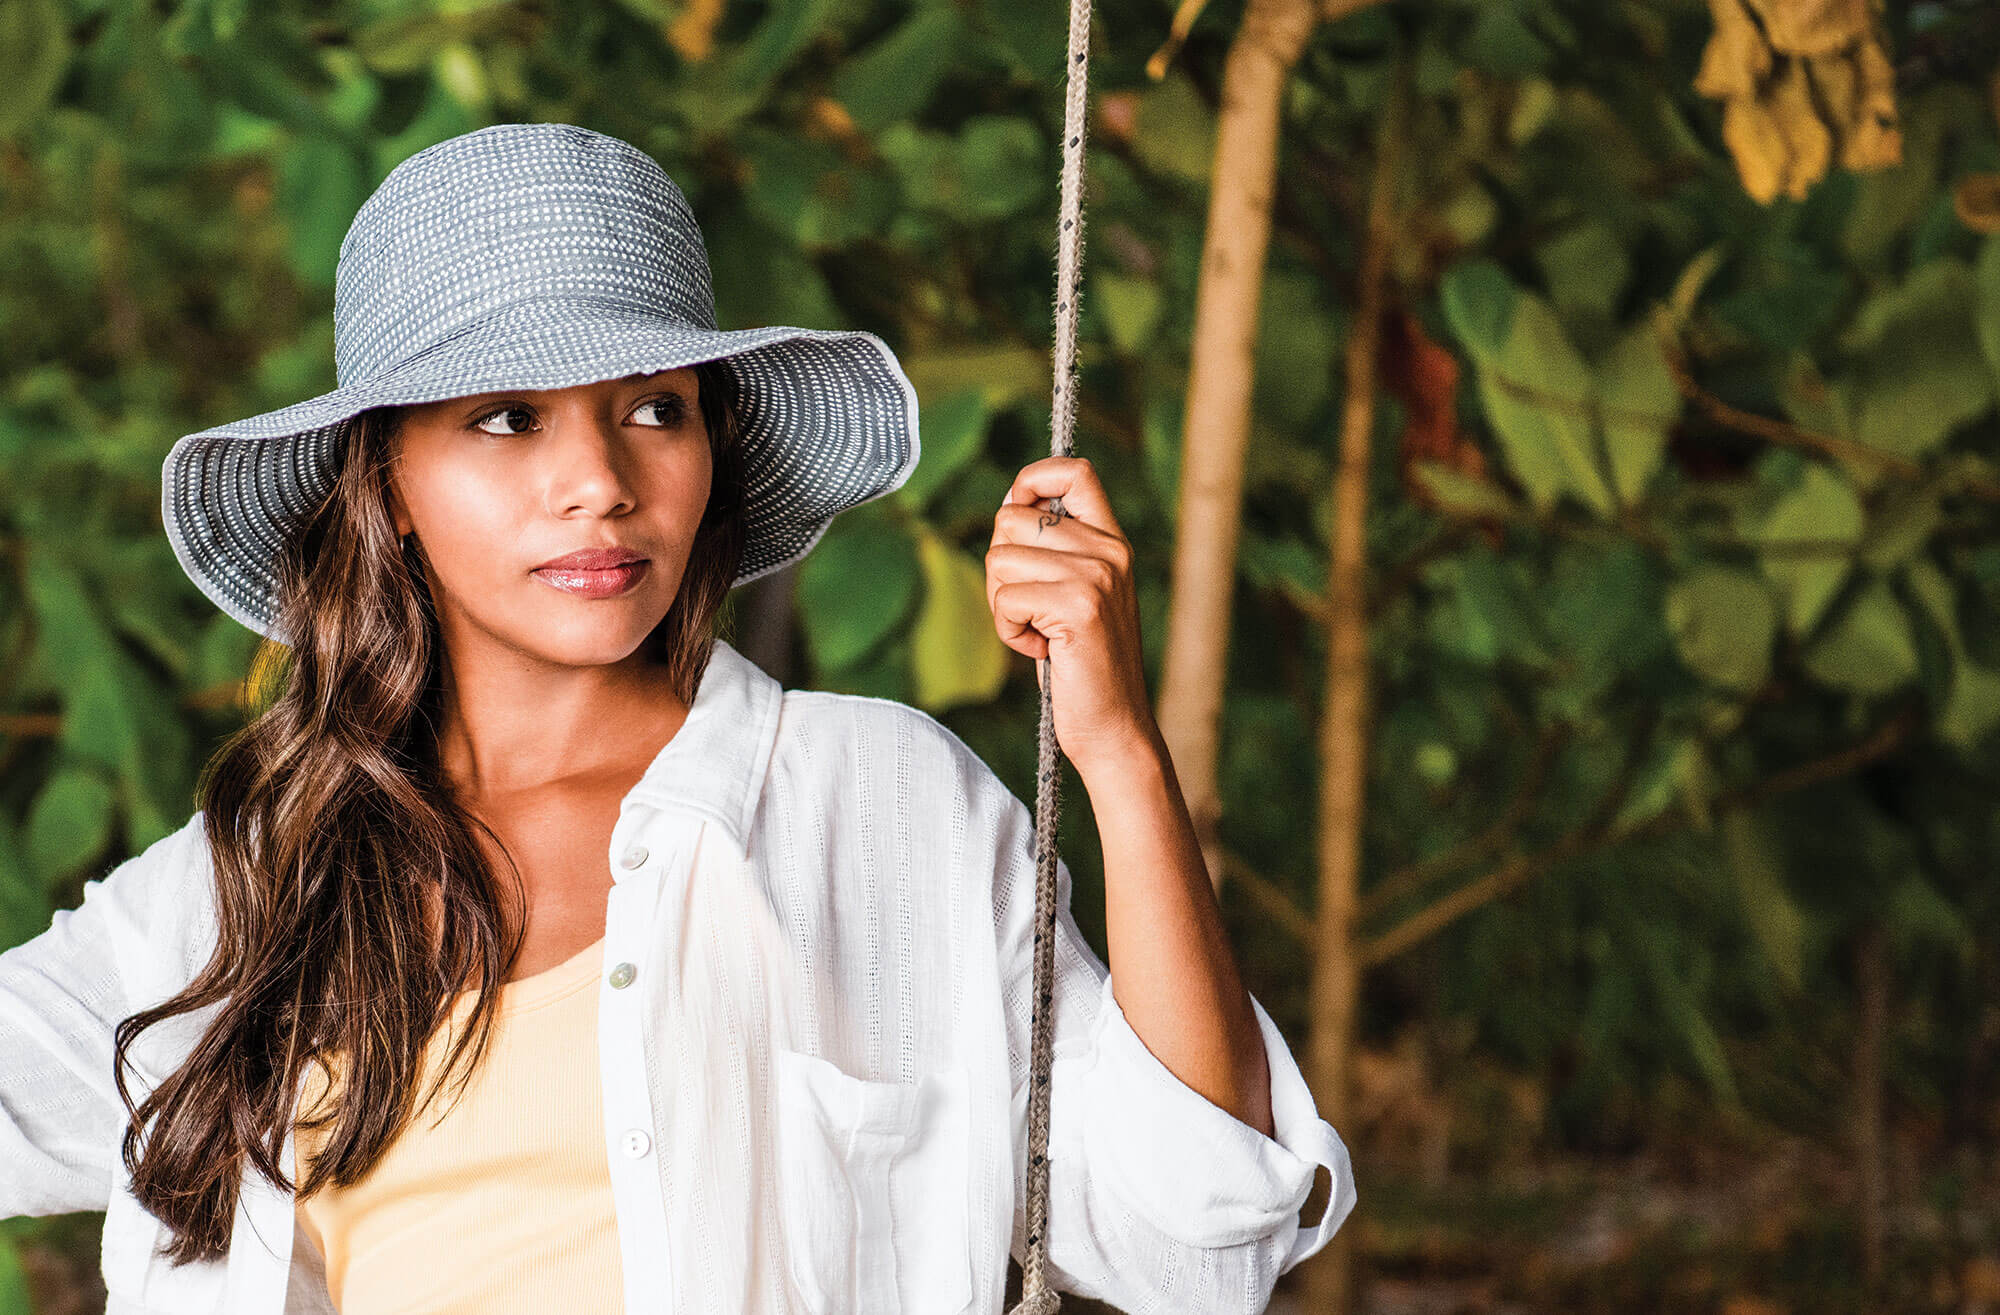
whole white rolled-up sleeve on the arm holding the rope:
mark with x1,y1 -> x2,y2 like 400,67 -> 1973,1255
974,747 -> 1356,1313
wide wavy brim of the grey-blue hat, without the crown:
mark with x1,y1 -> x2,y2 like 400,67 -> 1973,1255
160,298 -> 922,644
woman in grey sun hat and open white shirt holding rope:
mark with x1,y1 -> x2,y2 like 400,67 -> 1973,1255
0,124 -> 1354,1315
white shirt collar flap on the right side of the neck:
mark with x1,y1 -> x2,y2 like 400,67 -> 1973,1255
626,638 -> 784,855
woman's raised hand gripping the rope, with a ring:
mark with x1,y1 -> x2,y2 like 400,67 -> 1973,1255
986,456 -> 1160,777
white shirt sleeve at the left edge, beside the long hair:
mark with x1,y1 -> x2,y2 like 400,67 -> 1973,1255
0,813 -> 200,1219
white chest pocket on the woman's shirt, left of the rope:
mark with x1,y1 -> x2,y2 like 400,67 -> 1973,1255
774,1047 -> 972,1315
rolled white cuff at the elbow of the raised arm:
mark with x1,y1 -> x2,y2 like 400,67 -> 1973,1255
1086,975 -> 1354,1273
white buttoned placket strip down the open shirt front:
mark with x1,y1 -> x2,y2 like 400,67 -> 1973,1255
598,807 -> 692,1311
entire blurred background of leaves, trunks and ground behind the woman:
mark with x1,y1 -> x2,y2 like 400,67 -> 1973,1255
0,0 -> 2000,1315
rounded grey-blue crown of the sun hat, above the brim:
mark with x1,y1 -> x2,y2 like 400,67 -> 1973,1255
334,124 -> 716,388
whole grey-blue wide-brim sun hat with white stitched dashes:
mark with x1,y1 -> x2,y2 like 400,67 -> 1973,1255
160,124 -> 920,644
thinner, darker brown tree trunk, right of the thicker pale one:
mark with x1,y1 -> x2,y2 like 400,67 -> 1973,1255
1302,58 -> 1402,1315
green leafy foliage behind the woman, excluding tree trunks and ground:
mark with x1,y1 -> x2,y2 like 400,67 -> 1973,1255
0,0 -> 2000,1309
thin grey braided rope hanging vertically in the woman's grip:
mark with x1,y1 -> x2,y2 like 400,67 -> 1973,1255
1010,0 -> 1090,1315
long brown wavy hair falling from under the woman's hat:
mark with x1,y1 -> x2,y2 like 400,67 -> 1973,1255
114,362 -> 744,1265
